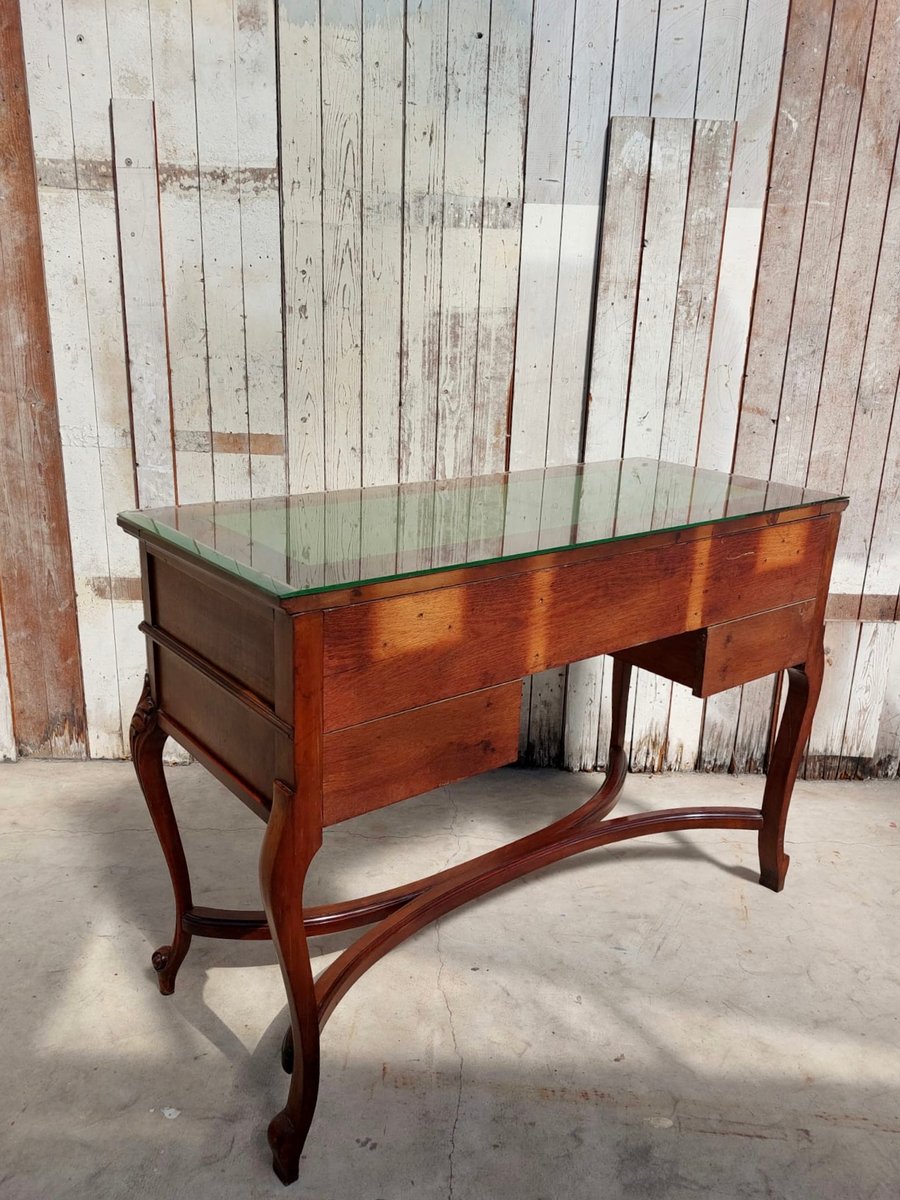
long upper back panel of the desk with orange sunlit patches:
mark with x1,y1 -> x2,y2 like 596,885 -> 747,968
324,517 -> 833,730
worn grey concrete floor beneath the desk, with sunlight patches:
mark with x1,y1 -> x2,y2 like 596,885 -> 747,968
0,762 -> 900,1200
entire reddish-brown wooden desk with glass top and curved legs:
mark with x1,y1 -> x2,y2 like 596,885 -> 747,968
120,460 -> 846,1183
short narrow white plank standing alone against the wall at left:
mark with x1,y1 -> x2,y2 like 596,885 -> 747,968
113,98 -> 175,508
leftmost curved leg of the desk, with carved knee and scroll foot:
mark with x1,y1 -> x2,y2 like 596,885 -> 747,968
130,676 -> 193,996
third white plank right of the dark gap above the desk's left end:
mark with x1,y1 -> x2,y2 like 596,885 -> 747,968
361,0 -> 404,485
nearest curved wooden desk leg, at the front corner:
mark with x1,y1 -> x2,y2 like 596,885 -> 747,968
259,784 -> 322,1183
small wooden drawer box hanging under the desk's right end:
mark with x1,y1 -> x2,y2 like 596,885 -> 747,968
614,600 -> 816,696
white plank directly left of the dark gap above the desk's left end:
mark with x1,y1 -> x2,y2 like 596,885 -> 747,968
234,0 -> 285,496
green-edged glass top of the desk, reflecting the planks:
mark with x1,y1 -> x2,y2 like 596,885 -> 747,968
120,458 -> 844,598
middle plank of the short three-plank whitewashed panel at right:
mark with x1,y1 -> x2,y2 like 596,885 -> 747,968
624,118 -> 694,458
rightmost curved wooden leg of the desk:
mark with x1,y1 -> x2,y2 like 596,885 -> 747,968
760,638 -> 824,892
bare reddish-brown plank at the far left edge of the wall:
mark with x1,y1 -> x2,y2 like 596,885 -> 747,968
0,0 -> 85,756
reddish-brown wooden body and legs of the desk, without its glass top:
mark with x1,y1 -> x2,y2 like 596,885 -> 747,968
123,489 -> 840,1182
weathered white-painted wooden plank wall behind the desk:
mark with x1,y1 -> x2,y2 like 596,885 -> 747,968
7,0 -> 900,774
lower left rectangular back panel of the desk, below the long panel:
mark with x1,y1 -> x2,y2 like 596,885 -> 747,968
323,680 -> 522,824
